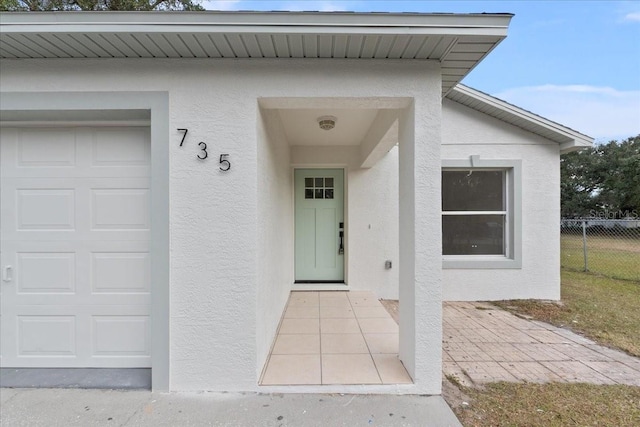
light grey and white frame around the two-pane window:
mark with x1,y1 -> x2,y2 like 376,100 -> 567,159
441,156 -> 522,269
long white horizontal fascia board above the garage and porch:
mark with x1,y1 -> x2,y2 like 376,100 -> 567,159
0,12 -> 513,36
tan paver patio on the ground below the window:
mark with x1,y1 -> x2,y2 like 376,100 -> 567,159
443,302 -> 640,386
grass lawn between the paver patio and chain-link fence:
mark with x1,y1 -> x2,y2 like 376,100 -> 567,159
496,270 -> 640,357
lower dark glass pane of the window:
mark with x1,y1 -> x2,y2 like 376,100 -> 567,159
442,215 -> 505,255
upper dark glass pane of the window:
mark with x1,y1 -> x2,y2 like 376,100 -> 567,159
442,170 -> 505,211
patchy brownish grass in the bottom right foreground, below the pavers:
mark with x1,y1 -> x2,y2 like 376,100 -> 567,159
454,383 -> 640,427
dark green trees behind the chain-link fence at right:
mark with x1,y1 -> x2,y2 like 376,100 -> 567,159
560,135 -> 640,218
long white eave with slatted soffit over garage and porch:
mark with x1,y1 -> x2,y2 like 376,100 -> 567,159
0,12 -> 513,94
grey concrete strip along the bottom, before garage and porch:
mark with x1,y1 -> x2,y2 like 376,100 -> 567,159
0,388 -> 461,427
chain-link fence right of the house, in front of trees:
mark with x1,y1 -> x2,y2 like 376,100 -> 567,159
560,218 -> 640,282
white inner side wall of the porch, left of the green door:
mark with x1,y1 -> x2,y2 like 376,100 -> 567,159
256,108 -> 294,375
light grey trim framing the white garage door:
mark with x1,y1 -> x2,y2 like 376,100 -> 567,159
0,92 -> 170,391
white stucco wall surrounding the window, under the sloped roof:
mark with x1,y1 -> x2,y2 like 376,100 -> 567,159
442,99 -> 560,301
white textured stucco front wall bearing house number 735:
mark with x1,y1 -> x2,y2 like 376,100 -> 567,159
0,59 -> 441,393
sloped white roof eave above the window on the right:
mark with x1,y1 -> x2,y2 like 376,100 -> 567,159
447,84 -> 593,153
